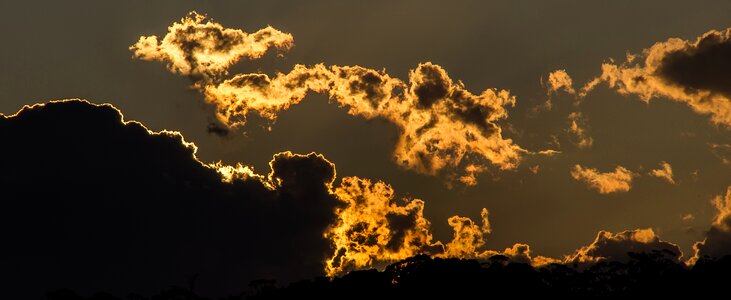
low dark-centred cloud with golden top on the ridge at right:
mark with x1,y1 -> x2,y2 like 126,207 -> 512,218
564,228 -> 683,264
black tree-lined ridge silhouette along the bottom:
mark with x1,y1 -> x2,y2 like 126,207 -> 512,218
41,251 -> 731,300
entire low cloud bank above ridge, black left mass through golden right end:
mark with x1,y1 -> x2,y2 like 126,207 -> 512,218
5,100 -> 731,297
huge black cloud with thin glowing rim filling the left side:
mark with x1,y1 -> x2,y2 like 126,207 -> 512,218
0,100 -> 340,296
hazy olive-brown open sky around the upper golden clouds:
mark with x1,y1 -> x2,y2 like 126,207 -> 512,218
0,0 -> 731,257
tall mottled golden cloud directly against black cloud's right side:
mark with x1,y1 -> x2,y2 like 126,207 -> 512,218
325,177 -> 443,275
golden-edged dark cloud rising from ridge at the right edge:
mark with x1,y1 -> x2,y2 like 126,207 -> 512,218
690,187 -> 731,263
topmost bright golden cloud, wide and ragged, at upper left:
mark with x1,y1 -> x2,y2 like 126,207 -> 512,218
129,12 -> 294,79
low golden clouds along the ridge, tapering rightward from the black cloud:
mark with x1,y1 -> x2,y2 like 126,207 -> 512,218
325,177 -> 558,276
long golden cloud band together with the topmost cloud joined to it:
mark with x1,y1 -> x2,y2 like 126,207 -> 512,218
130,13 -> 554,185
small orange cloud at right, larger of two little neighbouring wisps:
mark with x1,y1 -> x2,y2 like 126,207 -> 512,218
571,164 -> 635,194
